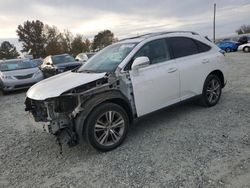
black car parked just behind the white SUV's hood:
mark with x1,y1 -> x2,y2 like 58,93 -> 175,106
40,54 -> 82,78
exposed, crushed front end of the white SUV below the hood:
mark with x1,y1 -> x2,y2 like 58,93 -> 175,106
25,95 -> 78,146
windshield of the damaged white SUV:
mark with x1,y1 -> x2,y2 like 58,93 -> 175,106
78,43 -> 137,72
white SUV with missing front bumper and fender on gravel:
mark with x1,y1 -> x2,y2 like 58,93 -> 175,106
25,31 -> 226,151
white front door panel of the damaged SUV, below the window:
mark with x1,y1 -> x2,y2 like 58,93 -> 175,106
130,60 -> 180,116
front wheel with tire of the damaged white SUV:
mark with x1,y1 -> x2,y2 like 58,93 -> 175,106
83,103 -> 129,152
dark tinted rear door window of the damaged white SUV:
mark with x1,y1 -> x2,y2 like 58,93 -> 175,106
167,37 -> 199,58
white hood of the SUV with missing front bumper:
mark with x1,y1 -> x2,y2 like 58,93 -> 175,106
27,71 -> 106,100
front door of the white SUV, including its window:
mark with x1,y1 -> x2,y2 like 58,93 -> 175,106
130,39 -> 180,116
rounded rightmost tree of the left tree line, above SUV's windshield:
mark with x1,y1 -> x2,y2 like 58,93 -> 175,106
92,30 -> 114,51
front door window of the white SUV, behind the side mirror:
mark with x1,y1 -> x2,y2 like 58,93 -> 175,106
124,39 -> 171,70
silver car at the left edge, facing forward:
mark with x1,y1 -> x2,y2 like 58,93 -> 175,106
0,59 -> 43,93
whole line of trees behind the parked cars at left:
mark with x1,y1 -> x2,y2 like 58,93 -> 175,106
0,20 -> 118,59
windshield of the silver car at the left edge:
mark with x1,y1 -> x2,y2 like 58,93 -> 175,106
0,60 -> 36,72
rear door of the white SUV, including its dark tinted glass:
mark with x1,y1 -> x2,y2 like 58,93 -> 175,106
167,37 -> 212,100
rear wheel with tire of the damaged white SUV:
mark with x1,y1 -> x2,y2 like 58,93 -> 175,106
201,74 -> 222,107
